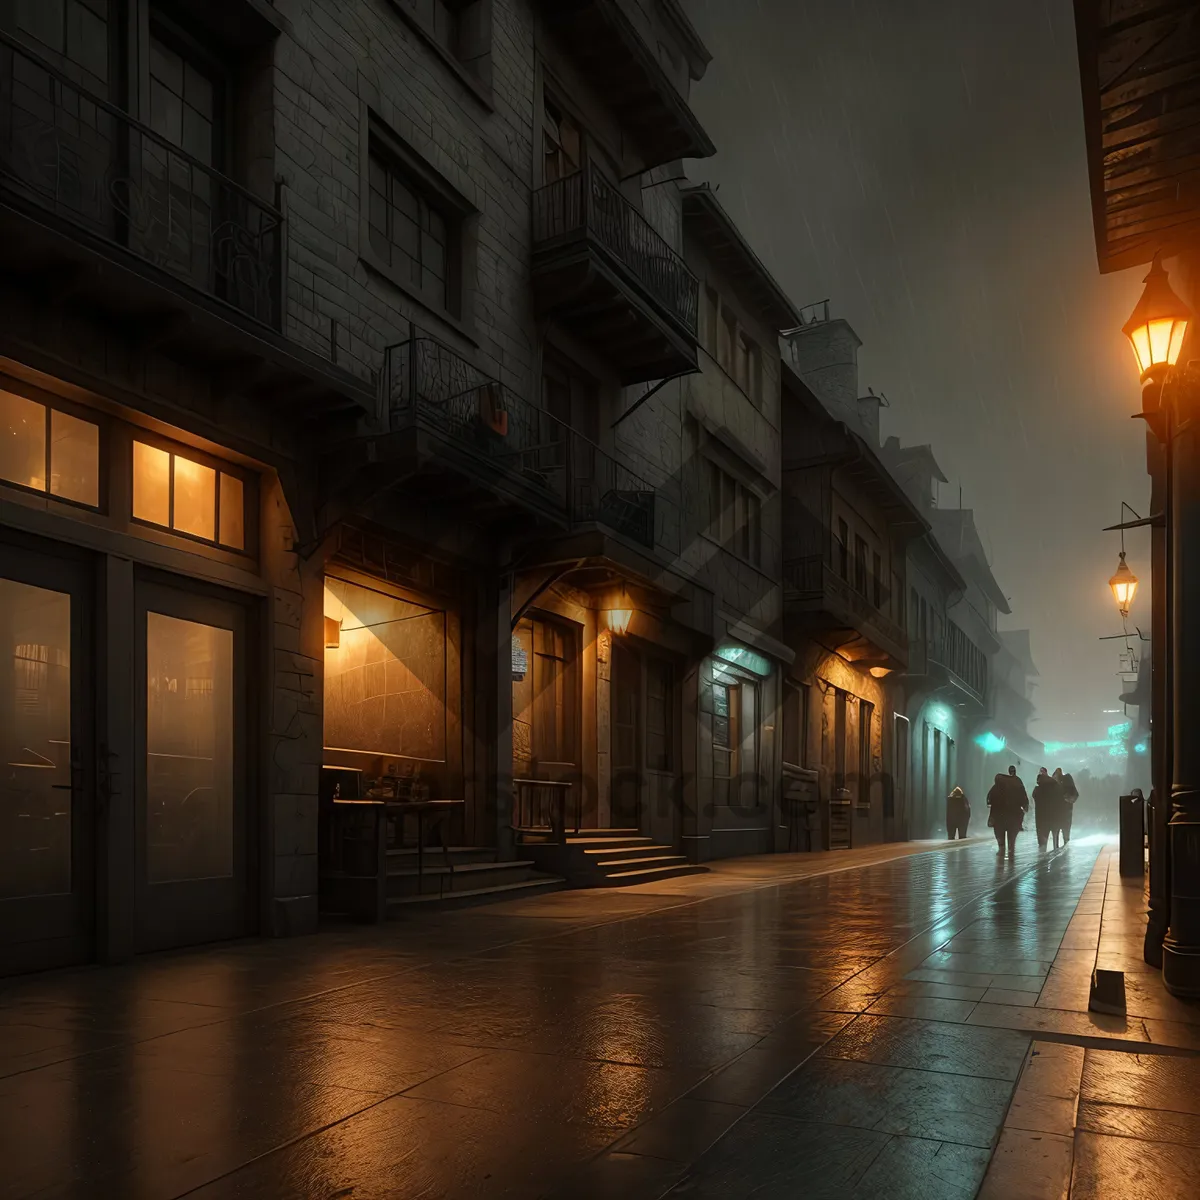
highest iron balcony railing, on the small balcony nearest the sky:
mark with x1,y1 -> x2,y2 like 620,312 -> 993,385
533,166 -> 700,341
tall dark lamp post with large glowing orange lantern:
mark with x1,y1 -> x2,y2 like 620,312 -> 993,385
1114,256 -> 1200,996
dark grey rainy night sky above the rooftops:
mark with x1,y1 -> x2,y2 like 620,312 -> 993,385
686,0 -> 1150,740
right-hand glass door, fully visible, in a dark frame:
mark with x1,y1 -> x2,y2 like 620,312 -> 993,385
137,583 -> 251,950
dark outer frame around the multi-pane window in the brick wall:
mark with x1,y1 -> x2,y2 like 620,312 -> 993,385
359,111 -> 479,328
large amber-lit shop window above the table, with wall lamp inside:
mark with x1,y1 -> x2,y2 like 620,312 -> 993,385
324,576 -> 446,762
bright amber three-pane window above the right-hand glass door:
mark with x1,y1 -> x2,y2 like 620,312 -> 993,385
133,440 -> 246,550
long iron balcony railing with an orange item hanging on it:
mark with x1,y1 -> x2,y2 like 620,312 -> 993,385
384,337 -> 661,550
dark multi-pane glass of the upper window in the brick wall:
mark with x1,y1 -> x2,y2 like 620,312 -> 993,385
367,134 -> 461,316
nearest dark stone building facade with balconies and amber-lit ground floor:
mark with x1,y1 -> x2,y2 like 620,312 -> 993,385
0,0 -> 779,971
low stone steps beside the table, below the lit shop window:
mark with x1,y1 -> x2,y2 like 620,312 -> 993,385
388,846 -> 568,914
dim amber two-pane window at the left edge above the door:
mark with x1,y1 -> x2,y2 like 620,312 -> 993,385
0,391 -> 100,509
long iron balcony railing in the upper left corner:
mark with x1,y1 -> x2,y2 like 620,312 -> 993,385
0,34 -> 283,329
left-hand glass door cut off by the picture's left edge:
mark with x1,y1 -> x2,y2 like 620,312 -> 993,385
0,539 -> 95,973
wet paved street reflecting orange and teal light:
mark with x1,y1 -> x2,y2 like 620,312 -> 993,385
0,842 -> 1200,1200
